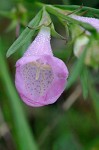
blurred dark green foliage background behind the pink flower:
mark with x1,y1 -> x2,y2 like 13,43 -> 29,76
0,0 -> 99,150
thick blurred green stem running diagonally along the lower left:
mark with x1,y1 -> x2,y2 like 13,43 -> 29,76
0,45 -> 37,150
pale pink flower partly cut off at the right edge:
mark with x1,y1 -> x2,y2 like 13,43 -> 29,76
71,15 -> 99,32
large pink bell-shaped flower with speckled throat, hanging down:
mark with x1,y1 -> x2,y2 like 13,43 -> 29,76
15,27 -> 68,107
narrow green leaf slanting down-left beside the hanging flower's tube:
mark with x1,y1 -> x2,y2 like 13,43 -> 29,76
6,10 -> 42,57
